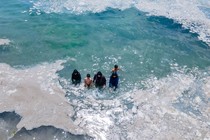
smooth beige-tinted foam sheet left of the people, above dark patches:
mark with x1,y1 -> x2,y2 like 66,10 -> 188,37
0,61 -> 83,134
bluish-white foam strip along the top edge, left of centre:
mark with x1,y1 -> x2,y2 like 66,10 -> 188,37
31,0 -> 133,14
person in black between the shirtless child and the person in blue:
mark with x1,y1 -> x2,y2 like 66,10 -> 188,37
93,71 -> 106,88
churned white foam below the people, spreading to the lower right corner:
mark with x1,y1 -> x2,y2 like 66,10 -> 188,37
64,65 -> 210,140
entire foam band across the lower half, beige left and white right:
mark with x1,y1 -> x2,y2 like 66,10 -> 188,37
0,58 -> 210,140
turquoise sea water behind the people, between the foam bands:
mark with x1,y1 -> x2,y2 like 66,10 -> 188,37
0,0 -> 210,139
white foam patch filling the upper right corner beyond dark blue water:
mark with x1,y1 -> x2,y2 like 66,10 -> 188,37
136,0 -> 210,45
